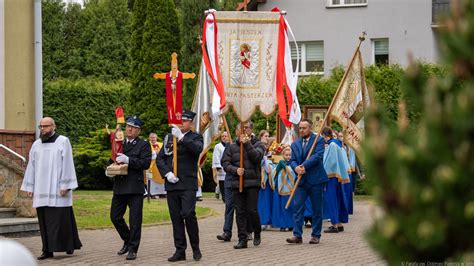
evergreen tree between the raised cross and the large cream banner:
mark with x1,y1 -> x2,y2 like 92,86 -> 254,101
178,0 -> 216,108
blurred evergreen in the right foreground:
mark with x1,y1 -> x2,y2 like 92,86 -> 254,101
365,1 -> 474,265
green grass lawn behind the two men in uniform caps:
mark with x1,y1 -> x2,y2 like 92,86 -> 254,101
73,190 -> 212,229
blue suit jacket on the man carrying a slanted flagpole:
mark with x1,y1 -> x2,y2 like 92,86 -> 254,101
290,134 -> 328,187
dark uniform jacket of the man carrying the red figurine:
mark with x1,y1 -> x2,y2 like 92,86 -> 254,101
109,138 -> 151,195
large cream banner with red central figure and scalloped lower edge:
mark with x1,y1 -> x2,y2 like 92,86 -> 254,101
215,12 -> 280,121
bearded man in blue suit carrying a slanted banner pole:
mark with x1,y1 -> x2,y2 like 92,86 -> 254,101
286,119 -> 328,244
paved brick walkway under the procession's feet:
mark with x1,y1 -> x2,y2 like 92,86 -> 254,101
9,198 -> 384,265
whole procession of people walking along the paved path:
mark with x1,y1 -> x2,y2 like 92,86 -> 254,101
21,111 -> 362,262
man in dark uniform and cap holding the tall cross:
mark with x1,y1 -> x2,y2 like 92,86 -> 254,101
156,111 -> 204,262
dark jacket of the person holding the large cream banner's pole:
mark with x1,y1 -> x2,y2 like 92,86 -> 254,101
221,136 -> 266,189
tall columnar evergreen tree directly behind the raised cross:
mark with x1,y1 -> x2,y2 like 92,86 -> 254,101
130,0 -> 181,136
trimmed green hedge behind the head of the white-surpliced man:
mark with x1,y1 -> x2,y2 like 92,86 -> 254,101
43,79 -> 130,144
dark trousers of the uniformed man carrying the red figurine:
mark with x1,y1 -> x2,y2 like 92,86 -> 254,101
110,194 -> 143,252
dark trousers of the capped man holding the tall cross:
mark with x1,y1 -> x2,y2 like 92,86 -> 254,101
166,190 -> 199,254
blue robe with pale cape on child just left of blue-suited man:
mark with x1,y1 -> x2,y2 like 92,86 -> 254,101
272,160 -> 296,228
